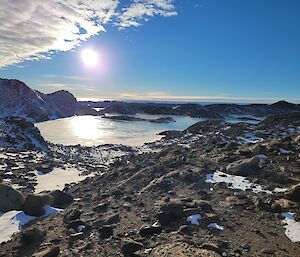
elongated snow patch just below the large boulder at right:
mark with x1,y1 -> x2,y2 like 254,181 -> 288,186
205,171 -> 272,194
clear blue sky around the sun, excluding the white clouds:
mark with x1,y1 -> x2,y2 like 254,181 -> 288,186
0,0 -> 300,102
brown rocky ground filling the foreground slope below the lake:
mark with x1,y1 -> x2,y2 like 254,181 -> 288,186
0,113 -> 300,257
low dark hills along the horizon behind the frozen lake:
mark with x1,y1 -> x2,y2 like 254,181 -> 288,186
81,101 -> 300,119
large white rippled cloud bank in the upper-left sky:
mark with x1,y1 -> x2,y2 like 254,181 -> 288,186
0,0 -> 176,67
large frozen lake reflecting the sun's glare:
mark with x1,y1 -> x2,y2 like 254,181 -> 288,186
36,115 -> 203,146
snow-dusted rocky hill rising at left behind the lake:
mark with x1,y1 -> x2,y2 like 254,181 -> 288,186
0,79 -> 97,122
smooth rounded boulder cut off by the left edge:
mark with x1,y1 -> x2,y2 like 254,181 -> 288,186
0,184 -> 24,212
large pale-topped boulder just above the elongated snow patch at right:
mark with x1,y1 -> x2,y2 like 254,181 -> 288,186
226,156 -> 260,176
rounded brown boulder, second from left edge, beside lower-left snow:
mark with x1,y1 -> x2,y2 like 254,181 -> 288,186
23,194 -> 53,216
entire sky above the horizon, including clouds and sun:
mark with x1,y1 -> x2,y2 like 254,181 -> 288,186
0,0 -> 300,103
